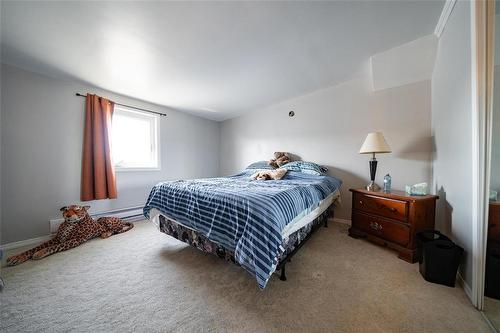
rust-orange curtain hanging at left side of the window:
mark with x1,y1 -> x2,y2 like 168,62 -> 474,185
80,94 -> 117,201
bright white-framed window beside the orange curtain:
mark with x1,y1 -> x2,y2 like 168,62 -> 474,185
111,106 -> 160,171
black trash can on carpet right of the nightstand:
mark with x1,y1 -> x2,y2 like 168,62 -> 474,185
417,231 -> 464,287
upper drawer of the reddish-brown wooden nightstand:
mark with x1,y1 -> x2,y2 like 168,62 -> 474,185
353,193 -> 408,222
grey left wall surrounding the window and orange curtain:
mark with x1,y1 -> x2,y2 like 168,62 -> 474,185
1,65 -> 219,244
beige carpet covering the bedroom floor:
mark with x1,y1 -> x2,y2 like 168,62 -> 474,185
0,222 -> 489,332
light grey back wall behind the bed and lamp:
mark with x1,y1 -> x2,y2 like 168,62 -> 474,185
220,77 -> 432,219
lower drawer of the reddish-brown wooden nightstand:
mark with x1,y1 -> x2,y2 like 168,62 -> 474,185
352,211 -> 410,246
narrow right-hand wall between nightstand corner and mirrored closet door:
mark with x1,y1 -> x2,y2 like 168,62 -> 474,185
432,1 -> 472,285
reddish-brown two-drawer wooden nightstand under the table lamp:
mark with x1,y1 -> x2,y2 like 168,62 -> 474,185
349,189 -> 438,263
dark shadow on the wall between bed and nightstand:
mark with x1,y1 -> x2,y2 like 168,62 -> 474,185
325,165 -> 367,220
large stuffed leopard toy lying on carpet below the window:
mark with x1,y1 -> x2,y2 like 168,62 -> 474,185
7,205 -> 134,266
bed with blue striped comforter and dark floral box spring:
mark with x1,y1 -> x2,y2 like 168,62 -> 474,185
144,166 -> 342,289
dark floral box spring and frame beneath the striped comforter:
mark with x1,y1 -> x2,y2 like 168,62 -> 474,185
158,203 -> 334,281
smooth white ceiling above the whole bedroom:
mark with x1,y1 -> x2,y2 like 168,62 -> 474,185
1,0 -> 444,120
